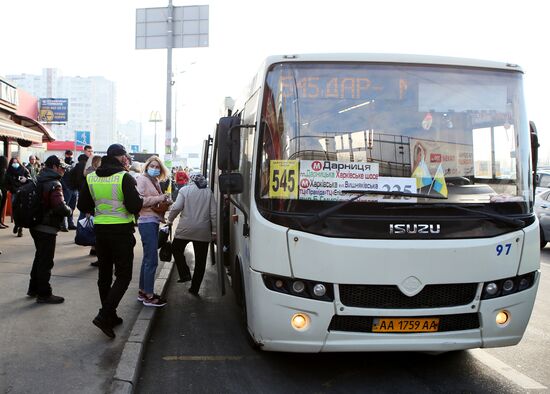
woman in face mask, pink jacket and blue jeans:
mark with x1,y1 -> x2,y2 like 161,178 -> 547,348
136,156 -> 169,307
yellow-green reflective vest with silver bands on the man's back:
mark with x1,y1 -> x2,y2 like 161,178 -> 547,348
86,171 -> 134,224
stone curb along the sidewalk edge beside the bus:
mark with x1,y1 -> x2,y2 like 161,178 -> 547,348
110,262 -> 174,394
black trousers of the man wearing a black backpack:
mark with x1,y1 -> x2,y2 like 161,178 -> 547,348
29,228 -> 57,297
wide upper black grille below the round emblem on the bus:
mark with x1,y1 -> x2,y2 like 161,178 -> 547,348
339,283 -> 478,309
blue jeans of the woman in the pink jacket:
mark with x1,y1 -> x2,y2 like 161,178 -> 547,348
138,223 -> 159,294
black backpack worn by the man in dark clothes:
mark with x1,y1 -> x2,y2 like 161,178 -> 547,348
12,179 -> 44,228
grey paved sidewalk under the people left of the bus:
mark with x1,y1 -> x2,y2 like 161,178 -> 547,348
0,224 -> 162,393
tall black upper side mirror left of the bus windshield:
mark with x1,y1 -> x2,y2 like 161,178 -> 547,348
217,116 -> 241,171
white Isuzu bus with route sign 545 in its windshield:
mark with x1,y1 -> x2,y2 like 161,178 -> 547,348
210,54 -> 540,352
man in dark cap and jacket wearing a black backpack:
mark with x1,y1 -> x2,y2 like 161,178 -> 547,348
27,156 -> 71,304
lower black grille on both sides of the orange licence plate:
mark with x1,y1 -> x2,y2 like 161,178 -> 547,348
328,313 -> 479,332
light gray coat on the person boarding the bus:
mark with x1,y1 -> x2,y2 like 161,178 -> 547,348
167,182 -> 216,242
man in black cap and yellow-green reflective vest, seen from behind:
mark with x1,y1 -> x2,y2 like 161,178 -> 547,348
78,144 -> 143,338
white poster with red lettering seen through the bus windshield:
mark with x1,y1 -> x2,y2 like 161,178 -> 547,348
410,138 -> 474,176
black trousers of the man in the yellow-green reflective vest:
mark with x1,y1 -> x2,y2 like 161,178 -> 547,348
95,231 -> 136,318
